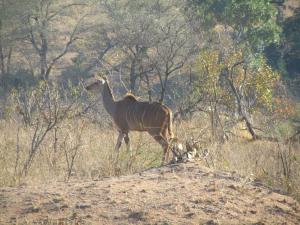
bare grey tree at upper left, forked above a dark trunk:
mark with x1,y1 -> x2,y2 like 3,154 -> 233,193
25,0 -> 84,80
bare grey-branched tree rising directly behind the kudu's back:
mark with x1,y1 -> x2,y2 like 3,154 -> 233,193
97,0 -> 197,102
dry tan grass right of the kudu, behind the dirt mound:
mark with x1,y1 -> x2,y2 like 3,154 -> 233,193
177,115 -> 300,200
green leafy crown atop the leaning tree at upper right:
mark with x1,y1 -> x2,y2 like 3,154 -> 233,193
189,0 -> 281,52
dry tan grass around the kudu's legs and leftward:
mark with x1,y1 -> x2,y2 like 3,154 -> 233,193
0,120 -> 162,186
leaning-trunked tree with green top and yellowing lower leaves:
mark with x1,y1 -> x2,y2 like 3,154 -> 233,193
186,0 -> 281,139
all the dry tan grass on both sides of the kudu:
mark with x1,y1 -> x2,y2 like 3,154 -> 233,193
0,110 -> 300,199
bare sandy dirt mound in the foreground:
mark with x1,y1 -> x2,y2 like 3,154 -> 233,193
0,162 -> 300,225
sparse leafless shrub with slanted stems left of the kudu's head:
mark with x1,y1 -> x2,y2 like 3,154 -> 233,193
11,81 -> 83,176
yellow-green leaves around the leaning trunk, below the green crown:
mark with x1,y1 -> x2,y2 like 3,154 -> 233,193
196,50 -> 279,110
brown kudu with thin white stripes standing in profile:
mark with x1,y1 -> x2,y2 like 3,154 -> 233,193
85,77 -> 173,164
